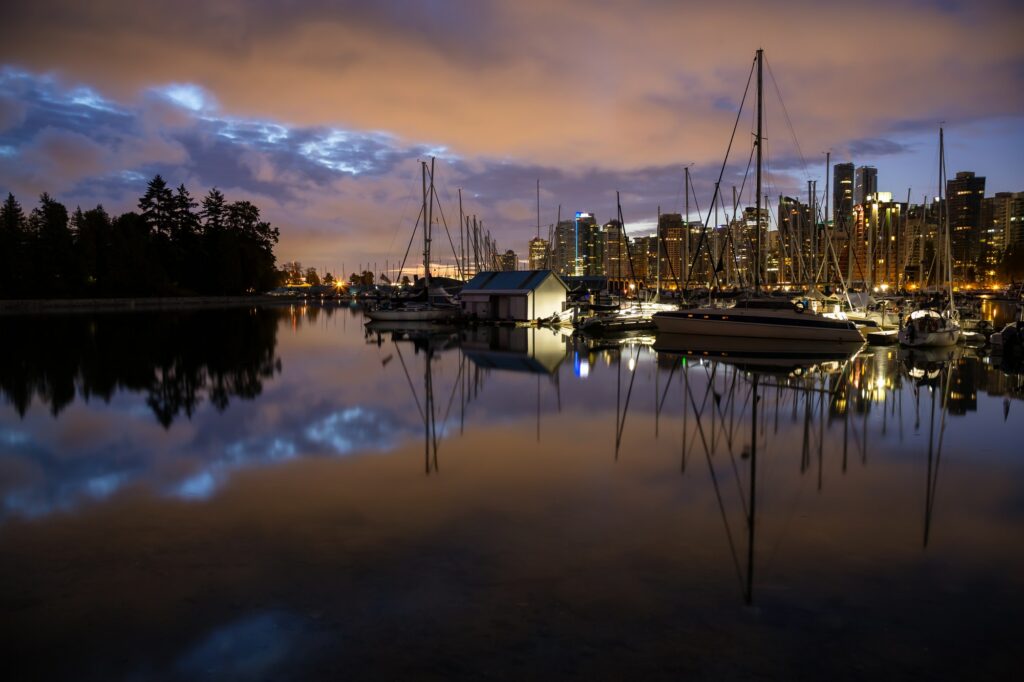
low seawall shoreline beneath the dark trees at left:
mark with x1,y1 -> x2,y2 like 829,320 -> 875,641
0,295 -> 319,315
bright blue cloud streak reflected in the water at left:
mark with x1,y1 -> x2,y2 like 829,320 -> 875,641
0,395 -> 415,517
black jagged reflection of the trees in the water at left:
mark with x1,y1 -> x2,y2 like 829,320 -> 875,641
0,308 -> 283,421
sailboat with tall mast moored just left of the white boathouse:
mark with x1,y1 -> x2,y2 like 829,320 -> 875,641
364,159 -> 462,323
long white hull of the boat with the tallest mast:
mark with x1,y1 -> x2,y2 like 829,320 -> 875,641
652,308 -> 864,343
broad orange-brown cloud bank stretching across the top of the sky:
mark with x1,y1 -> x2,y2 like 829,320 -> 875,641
0,1 -> 1024,168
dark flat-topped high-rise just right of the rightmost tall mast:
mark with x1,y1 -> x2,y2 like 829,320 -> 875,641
946,171 -> 986,283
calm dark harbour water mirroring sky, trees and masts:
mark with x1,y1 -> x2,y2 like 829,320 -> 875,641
0,307 -> 1024,680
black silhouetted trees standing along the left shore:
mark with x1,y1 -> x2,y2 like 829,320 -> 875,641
0,175 -> 280,298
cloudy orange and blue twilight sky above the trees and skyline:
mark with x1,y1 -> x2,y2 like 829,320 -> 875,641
0,0 -> 1024,272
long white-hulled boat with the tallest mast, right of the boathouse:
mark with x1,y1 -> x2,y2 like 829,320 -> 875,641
652,49 -> 864,346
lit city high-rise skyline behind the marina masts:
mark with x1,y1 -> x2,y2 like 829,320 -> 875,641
516,163 -> 1024,290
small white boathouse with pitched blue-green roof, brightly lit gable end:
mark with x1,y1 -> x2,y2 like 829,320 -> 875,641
461,270 -> 568,322
